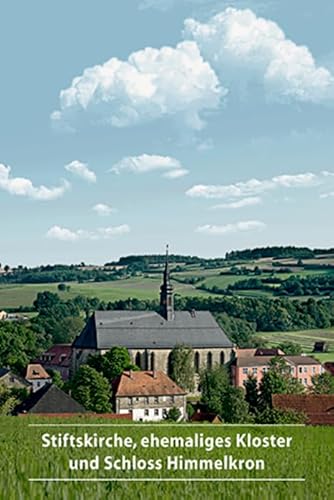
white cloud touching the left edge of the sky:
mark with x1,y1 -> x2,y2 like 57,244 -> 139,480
0,163 -> 70,201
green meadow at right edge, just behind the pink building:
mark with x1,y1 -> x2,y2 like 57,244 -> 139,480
257,328 -> 334,361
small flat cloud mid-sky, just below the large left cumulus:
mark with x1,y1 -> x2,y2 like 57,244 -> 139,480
110,154 -> 188,179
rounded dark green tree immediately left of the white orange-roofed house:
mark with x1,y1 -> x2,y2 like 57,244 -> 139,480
71,365 -> 111,413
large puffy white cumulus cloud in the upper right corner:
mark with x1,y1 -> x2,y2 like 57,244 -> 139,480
184,8 -> 334,102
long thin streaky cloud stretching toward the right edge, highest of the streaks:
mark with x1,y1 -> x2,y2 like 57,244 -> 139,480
186,172 -> 325,199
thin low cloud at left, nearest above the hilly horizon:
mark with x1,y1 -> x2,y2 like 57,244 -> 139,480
46,224 -> 130,241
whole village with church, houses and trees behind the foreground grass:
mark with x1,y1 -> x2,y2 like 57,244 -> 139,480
0,248 -> 334,424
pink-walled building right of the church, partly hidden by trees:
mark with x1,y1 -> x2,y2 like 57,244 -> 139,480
231,355 -> 323,387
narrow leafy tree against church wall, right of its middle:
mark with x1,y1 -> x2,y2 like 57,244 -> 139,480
169,345 -> 195,392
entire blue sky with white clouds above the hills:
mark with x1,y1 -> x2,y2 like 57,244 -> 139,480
0,0 -> 334,266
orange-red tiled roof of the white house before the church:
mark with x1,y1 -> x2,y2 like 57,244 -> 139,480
115,371 -> 186,397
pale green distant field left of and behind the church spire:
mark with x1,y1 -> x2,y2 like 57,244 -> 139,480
0,275 -> 214,310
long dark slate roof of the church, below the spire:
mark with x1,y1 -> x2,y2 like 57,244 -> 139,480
73,311 -> 232,349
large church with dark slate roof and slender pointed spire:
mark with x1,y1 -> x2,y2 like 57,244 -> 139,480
72,249 -> 233,374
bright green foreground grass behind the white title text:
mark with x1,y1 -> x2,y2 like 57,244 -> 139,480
0,417 -> 334,500
